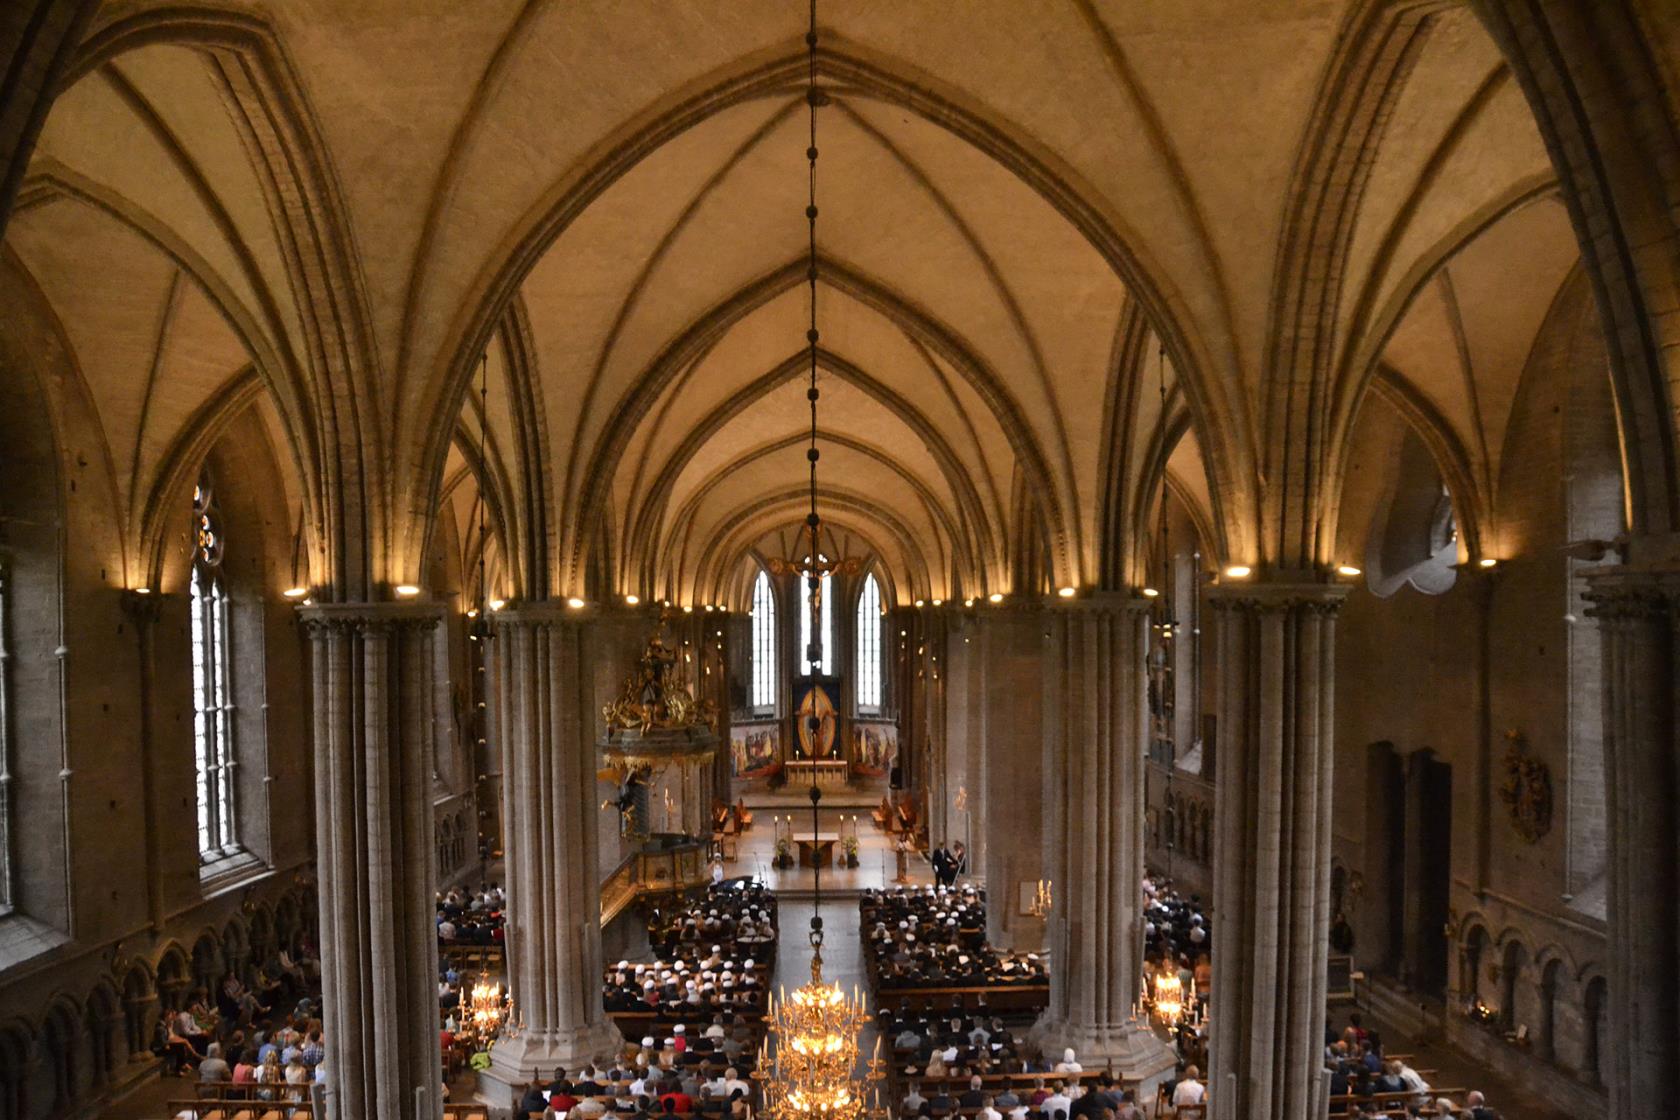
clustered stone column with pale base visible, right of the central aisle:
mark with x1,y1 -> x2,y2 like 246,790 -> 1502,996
1034,594 -> 1173,1088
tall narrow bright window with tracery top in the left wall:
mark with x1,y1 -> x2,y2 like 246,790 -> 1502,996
188,480 -> 239,863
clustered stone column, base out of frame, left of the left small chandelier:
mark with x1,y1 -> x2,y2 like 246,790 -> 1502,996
301,603 -> 444,1120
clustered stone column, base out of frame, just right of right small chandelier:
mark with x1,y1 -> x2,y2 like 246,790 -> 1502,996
1210,583 -> 1347,1120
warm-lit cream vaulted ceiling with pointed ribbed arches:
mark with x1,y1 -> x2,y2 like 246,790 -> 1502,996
7,0 -> 1619,603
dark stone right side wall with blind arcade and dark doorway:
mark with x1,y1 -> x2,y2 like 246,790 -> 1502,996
1332,272 -> 1621,1107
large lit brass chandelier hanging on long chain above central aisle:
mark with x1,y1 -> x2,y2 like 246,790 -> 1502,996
754,0 -> 885,1120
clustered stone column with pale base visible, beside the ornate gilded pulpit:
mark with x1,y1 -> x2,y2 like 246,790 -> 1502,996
480,603 -> 623,1105
